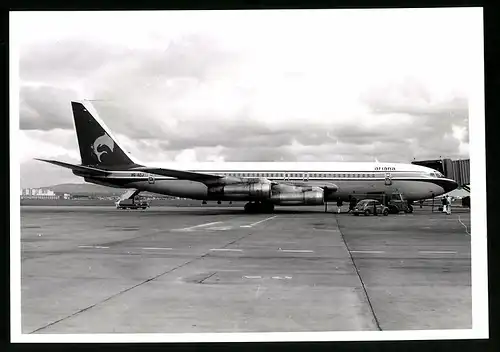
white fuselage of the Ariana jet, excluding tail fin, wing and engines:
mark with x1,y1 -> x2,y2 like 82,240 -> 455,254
86,162 -> 456,201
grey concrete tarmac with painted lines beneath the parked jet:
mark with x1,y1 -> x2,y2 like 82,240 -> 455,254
21,205 -> 472,334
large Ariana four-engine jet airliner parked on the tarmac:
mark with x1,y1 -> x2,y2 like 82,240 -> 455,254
36,100 -> 458,213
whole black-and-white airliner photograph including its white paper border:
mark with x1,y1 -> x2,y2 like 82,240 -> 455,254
9,7 -> 488,342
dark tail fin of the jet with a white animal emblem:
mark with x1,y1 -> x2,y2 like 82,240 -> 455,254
71,101 -> 141,169
